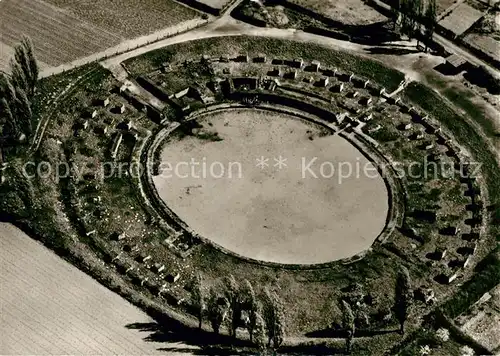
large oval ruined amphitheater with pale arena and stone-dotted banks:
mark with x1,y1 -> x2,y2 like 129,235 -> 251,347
6,37 -> 496,354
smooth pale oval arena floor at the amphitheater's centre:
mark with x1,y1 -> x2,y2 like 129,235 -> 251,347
155,110 -> 388,264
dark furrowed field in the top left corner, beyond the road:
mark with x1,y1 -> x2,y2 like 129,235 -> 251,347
0,0 -> 199,70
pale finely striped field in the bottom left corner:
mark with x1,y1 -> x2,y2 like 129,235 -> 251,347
0,224 -> 195,355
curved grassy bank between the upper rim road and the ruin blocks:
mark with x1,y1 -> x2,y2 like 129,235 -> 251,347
125,36 -> 404,91
